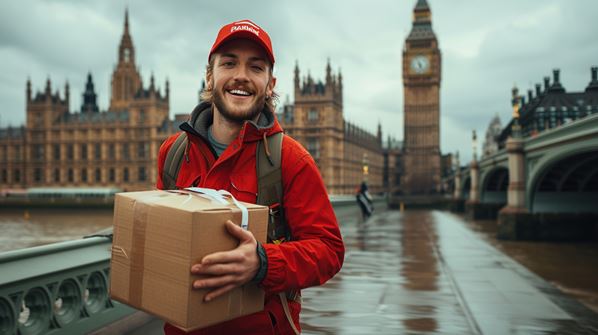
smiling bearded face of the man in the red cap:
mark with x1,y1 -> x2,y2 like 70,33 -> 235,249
206,39 -> 276,123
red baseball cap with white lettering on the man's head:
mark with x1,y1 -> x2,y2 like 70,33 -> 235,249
208,20 -> 274,65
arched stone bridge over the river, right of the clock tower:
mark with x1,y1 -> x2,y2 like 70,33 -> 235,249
447,113 -> 598,239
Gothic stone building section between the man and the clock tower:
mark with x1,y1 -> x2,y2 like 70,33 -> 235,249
279,62 -> 384,194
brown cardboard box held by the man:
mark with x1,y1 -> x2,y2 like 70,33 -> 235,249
110,191 -> 268,331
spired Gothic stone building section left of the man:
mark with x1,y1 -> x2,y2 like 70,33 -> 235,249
0,13 -> 176,190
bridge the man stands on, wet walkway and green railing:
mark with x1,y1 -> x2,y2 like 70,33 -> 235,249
0,199 -> 598,335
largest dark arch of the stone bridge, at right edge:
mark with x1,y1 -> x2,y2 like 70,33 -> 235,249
526,146 -> 598,213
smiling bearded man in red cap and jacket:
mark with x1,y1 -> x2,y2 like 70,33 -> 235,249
157,20 -> 344,334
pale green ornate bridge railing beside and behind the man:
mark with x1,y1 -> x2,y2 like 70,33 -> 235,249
0,197 -> 386,335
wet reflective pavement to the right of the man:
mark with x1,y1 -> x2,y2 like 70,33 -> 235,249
301,211 -> 598,334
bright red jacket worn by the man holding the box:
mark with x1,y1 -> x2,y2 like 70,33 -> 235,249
157,103 -> 345,334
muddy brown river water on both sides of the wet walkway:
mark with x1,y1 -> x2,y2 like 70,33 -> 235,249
0,209 -> 598,312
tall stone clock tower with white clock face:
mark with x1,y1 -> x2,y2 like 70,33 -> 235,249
401,0 -> 441,195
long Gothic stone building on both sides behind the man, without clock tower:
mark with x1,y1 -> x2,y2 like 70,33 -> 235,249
0,12 -> 401,194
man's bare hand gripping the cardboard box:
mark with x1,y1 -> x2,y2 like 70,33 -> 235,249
191,220 -> 260,302
